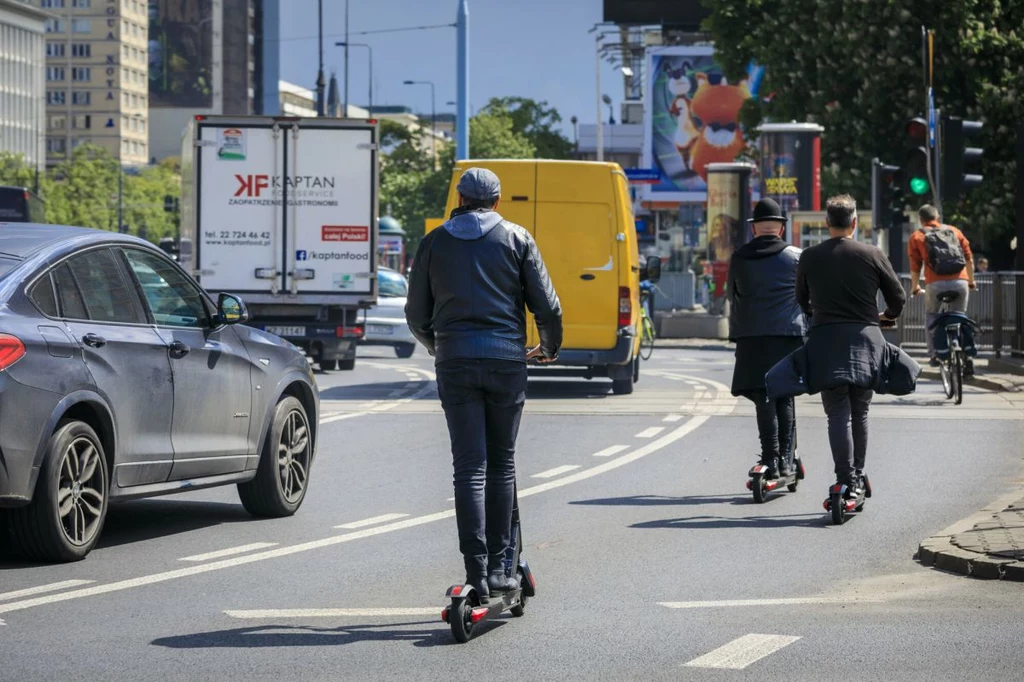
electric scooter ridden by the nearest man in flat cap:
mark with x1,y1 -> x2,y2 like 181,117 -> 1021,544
441,485 -> 537,643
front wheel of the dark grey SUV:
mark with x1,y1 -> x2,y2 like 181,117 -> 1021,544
239,395 -> 313,518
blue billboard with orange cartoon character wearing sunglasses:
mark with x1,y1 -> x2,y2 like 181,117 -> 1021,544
643,46 -> 763,202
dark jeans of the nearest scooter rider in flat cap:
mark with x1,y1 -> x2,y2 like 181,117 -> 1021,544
436,359 -> 526,558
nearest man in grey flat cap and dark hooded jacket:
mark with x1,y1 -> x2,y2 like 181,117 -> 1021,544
406,168 -> 562,602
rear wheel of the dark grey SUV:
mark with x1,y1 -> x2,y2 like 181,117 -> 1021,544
9,422 -> 110,561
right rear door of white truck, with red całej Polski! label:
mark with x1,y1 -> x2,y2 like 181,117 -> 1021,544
284,124 -> 377,298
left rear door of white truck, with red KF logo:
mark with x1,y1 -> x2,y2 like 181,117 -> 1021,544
196,125 -> 284,294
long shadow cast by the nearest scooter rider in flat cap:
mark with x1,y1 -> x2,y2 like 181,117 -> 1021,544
152,611 -> 504,649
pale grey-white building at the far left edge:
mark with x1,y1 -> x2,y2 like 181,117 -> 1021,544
0,0 -> 46,168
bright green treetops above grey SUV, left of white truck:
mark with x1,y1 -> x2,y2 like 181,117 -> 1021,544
0,144 -> 181,242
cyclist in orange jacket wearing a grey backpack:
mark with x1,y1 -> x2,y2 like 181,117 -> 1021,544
906,204 -> 978,364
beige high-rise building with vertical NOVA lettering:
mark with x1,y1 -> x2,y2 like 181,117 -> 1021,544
34,0 -> 150,166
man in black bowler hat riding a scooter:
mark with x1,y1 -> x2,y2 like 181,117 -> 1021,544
726,199 -> 807,478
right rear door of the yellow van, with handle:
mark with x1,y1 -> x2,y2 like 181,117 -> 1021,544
532,162 -> 629,350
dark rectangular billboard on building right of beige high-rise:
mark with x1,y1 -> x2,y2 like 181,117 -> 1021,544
150,0 -> 213,109
